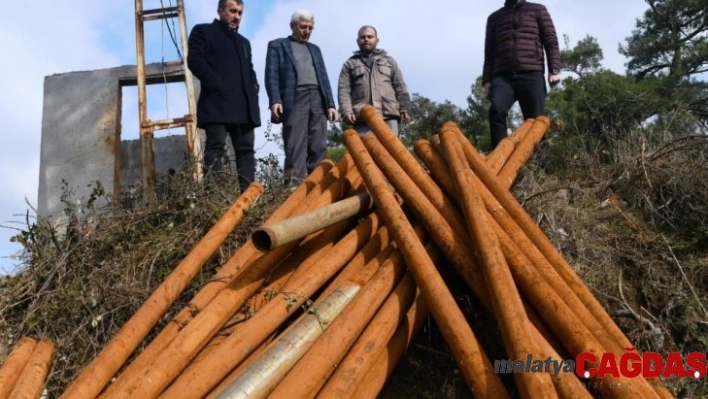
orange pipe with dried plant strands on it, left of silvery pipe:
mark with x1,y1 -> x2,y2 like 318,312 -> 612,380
161,214 -> 378,398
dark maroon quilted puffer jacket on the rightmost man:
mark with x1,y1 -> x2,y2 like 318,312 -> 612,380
482,0 -> 561,83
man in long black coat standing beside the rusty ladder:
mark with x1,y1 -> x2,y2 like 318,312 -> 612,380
187,0 -> 261,192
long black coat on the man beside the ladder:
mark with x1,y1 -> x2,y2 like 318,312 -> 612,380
187,19 -> 261,128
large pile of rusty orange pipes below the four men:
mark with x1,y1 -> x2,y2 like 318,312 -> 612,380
0,106 -> 671,399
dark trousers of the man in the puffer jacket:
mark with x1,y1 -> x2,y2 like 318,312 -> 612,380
489,72 -> 546,149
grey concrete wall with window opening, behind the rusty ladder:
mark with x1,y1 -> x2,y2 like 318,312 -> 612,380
37,64 -> 198,220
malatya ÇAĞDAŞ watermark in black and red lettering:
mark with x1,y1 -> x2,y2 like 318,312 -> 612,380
494,348 -> 708,379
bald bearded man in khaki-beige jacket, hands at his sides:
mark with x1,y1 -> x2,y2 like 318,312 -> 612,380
338,25 -> 411,133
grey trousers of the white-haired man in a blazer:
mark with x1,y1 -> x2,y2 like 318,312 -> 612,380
283,88 -> 327,184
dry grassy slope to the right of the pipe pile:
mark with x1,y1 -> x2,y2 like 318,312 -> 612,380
514,135 -> 708,397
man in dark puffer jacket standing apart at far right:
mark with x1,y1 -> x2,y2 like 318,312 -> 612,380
482,0 -> 561,149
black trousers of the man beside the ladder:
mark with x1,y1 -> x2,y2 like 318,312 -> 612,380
204,124 -> 256,192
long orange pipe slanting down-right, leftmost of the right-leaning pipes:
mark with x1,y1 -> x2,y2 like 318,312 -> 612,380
343,129 -> 509,398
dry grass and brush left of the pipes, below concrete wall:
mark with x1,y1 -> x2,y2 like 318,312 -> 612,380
0,170 -> 285,397
